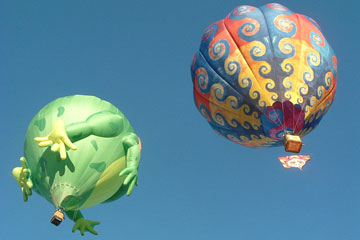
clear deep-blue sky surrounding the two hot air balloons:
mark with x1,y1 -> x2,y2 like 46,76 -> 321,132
0,0 -> 360,240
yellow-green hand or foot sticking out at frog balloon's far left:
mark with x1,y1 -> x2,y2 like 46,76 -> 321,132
12,157 -> 33,202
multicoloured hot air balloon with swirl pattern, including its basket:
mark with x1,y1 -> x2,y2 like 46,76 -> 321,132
191,3 -> 337,161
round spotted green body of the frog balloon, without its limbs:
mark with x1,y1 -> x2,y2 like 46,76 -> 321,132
24,95 -> 134,211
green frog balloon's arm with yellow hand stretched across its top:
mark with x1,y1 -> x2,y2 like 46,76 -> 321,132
34,111 -> 123,160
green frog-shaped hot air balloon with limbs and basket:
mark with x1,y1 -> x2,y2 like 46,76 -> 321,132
13,95 -> 141,235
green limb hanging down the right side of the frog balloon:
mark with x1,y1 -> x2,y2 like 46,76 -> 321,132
120,133 -> 141,196
